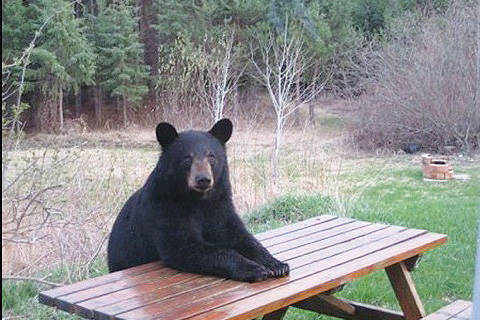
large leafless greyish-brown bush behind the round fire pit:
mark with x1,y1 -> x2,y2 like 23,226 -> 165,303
355,3 -> 480,152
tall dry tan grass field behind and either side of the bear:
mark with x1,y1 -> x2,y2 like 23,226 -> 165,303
2,105 -> 376,281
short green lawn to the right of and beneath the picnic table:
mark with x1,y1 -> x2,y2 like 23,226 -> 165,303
286,167 -> 480,320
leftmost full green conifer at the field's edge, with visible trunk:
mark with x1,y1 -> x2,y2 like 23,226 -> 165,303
28,0 -> 95,131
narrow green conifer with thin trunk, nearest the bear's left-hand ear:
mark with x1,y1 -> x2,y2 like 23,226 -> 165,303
94,1 -> 149,127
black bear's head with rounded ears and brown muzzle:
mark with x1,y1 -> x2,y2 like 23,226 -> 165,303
156,119 -> 233,199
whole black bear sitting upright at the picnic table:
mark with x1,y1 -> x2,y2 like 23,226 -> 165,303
108,119 -> 289,282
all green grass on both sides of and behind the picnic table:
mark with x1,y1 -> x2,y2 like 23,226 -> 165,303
2,159 -> 480,320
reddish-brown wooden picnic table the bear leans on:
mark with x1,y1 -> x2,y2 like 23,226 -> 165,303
39,215 -> 447,320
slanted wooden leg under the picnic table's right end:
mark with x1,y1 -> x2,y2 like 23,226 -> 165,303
385,261 -> 426,320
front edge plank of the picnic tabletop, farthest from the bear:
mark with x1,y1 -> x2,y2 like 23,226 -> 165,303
185,230 -> 446,320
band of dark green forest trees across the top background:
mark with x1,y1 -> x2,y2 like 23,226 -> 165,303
2,0 -> 458,129
